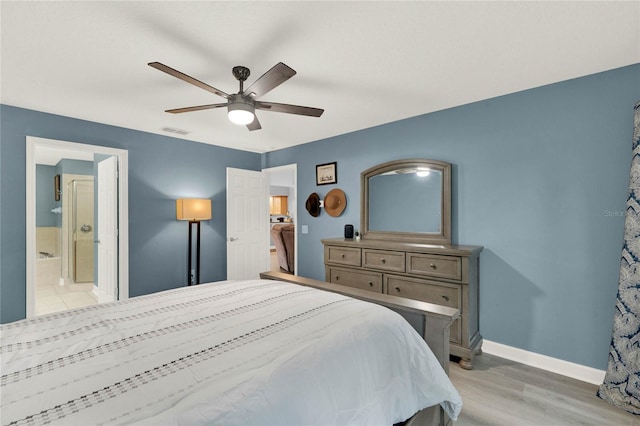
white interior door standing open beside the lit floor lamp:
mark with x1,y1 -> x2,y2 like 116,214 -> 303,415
227,167 -> 269,280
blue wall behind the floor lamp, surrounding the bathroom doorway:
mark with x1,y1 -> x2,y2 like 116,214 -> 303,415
0,105 -> 261,323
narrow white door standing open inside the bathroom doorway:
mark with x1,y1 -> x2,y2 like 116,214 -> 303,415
97,156 -> 118,303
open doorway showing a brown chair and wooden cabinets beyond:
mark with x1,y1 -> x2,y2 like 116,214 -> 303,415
263,164 -> 298,274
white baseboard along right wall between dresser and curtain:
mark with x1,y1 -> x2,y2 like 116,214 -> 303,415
482,340 -> 605,385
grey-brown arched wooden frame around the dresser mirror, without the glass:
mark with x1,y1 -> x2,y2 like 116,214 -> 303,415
360,158 -> 451,244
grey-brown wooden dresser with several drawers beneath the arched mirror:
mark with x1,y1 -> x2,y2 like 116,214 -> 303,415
322,238 -> 482,369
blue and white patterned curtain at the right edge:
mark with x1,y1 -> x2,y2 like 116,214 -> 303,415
598,102 -> 640,414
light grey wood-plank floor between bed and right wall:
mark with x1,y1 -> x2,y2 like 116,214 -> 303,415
449,353 -> 640,426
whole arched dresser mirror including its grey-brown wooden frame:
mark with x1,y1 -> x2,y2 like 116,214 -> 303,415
360,159 -> 451,244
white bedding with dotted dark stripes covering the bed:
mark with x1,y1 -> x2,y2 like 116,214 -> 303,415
0,280 -> 462,425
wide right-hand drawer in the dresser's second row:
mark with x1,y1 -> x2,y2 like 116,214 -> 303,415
385,275 -> 462,311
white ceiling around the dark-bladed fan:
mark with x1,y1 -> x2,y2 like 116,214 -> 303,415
0,0 -> 640,152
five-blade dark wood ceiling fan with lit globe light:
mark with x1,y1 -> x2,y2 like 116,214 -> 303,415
149,62 -> 324,130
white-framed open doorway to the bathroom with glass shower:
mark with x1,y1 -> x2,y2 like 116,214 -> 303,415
26,137 -> 129,318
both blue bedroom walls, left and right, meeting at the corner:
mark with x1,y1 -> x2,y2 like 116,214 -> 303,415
0,65 -> 640,369
